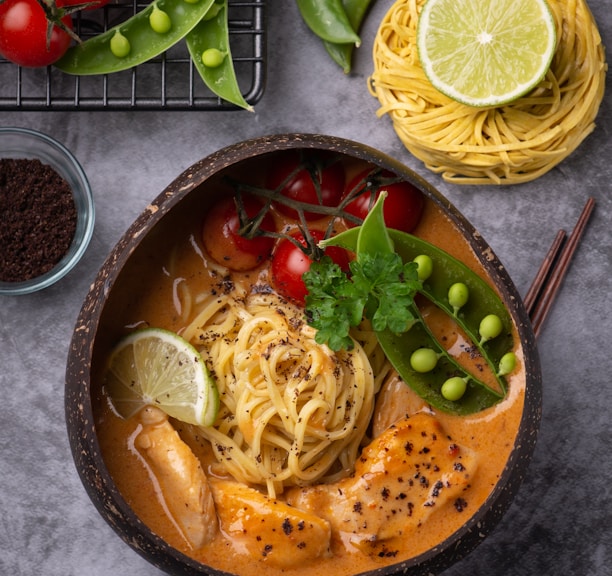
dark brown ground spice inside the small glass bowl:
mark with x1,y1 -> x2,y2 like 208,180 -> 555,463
0,158 -> 77,282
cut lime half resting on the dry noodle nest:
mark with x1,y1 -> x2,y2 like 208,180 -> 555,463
417,0 -> 556,106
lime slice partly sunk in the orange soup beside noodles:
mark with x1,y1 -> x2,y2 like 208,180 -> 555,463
105,328 -> 219,426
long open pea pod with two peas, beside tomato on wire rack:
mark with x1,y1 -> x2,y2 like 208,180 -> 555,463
55,0 -> 214,76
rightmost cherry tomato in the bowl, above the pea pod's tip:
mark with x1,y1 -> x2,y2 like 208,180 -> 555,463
345,170 -> 425,232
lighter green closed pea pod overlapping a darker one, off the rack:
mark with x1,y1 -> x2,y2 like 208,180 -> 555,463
296,0 -> 361,46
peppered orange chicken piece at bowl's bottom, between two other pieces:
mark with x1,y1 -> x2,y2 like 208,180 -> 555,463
210,478 -> 331,568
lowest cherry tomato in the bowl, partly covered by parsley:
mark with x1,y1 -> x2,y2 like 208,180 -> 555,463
270,230 -> 350,305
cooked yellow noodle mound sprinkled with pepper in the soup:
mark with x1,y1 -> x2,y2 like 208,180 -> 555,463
182,289 -> 386,497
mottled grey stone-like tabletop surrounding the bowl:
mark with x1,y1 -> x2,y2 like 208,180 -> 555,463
0,0 -> 612,576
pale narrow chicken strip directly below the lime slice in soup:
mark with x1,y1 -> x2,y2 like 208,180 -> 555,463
134,406 -> 219,549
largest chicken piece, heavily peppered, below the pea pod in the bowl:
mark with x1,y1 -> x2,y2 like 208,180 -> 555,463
287,413 -> 477,551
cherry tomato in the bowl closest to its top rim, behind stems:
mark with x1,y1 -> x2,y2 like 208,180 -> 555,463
267,151 -> 345,220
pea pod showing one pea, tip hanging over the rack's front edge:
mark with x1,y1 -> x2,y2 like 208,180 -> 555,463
185,0 -> 253,111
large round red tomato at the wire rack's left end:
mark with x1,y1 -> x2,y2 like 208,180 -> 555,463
0,0 -> 72,67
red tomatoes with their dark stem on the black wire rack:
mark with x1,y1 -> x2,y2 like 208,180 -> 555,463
0,0 -> 109,67
